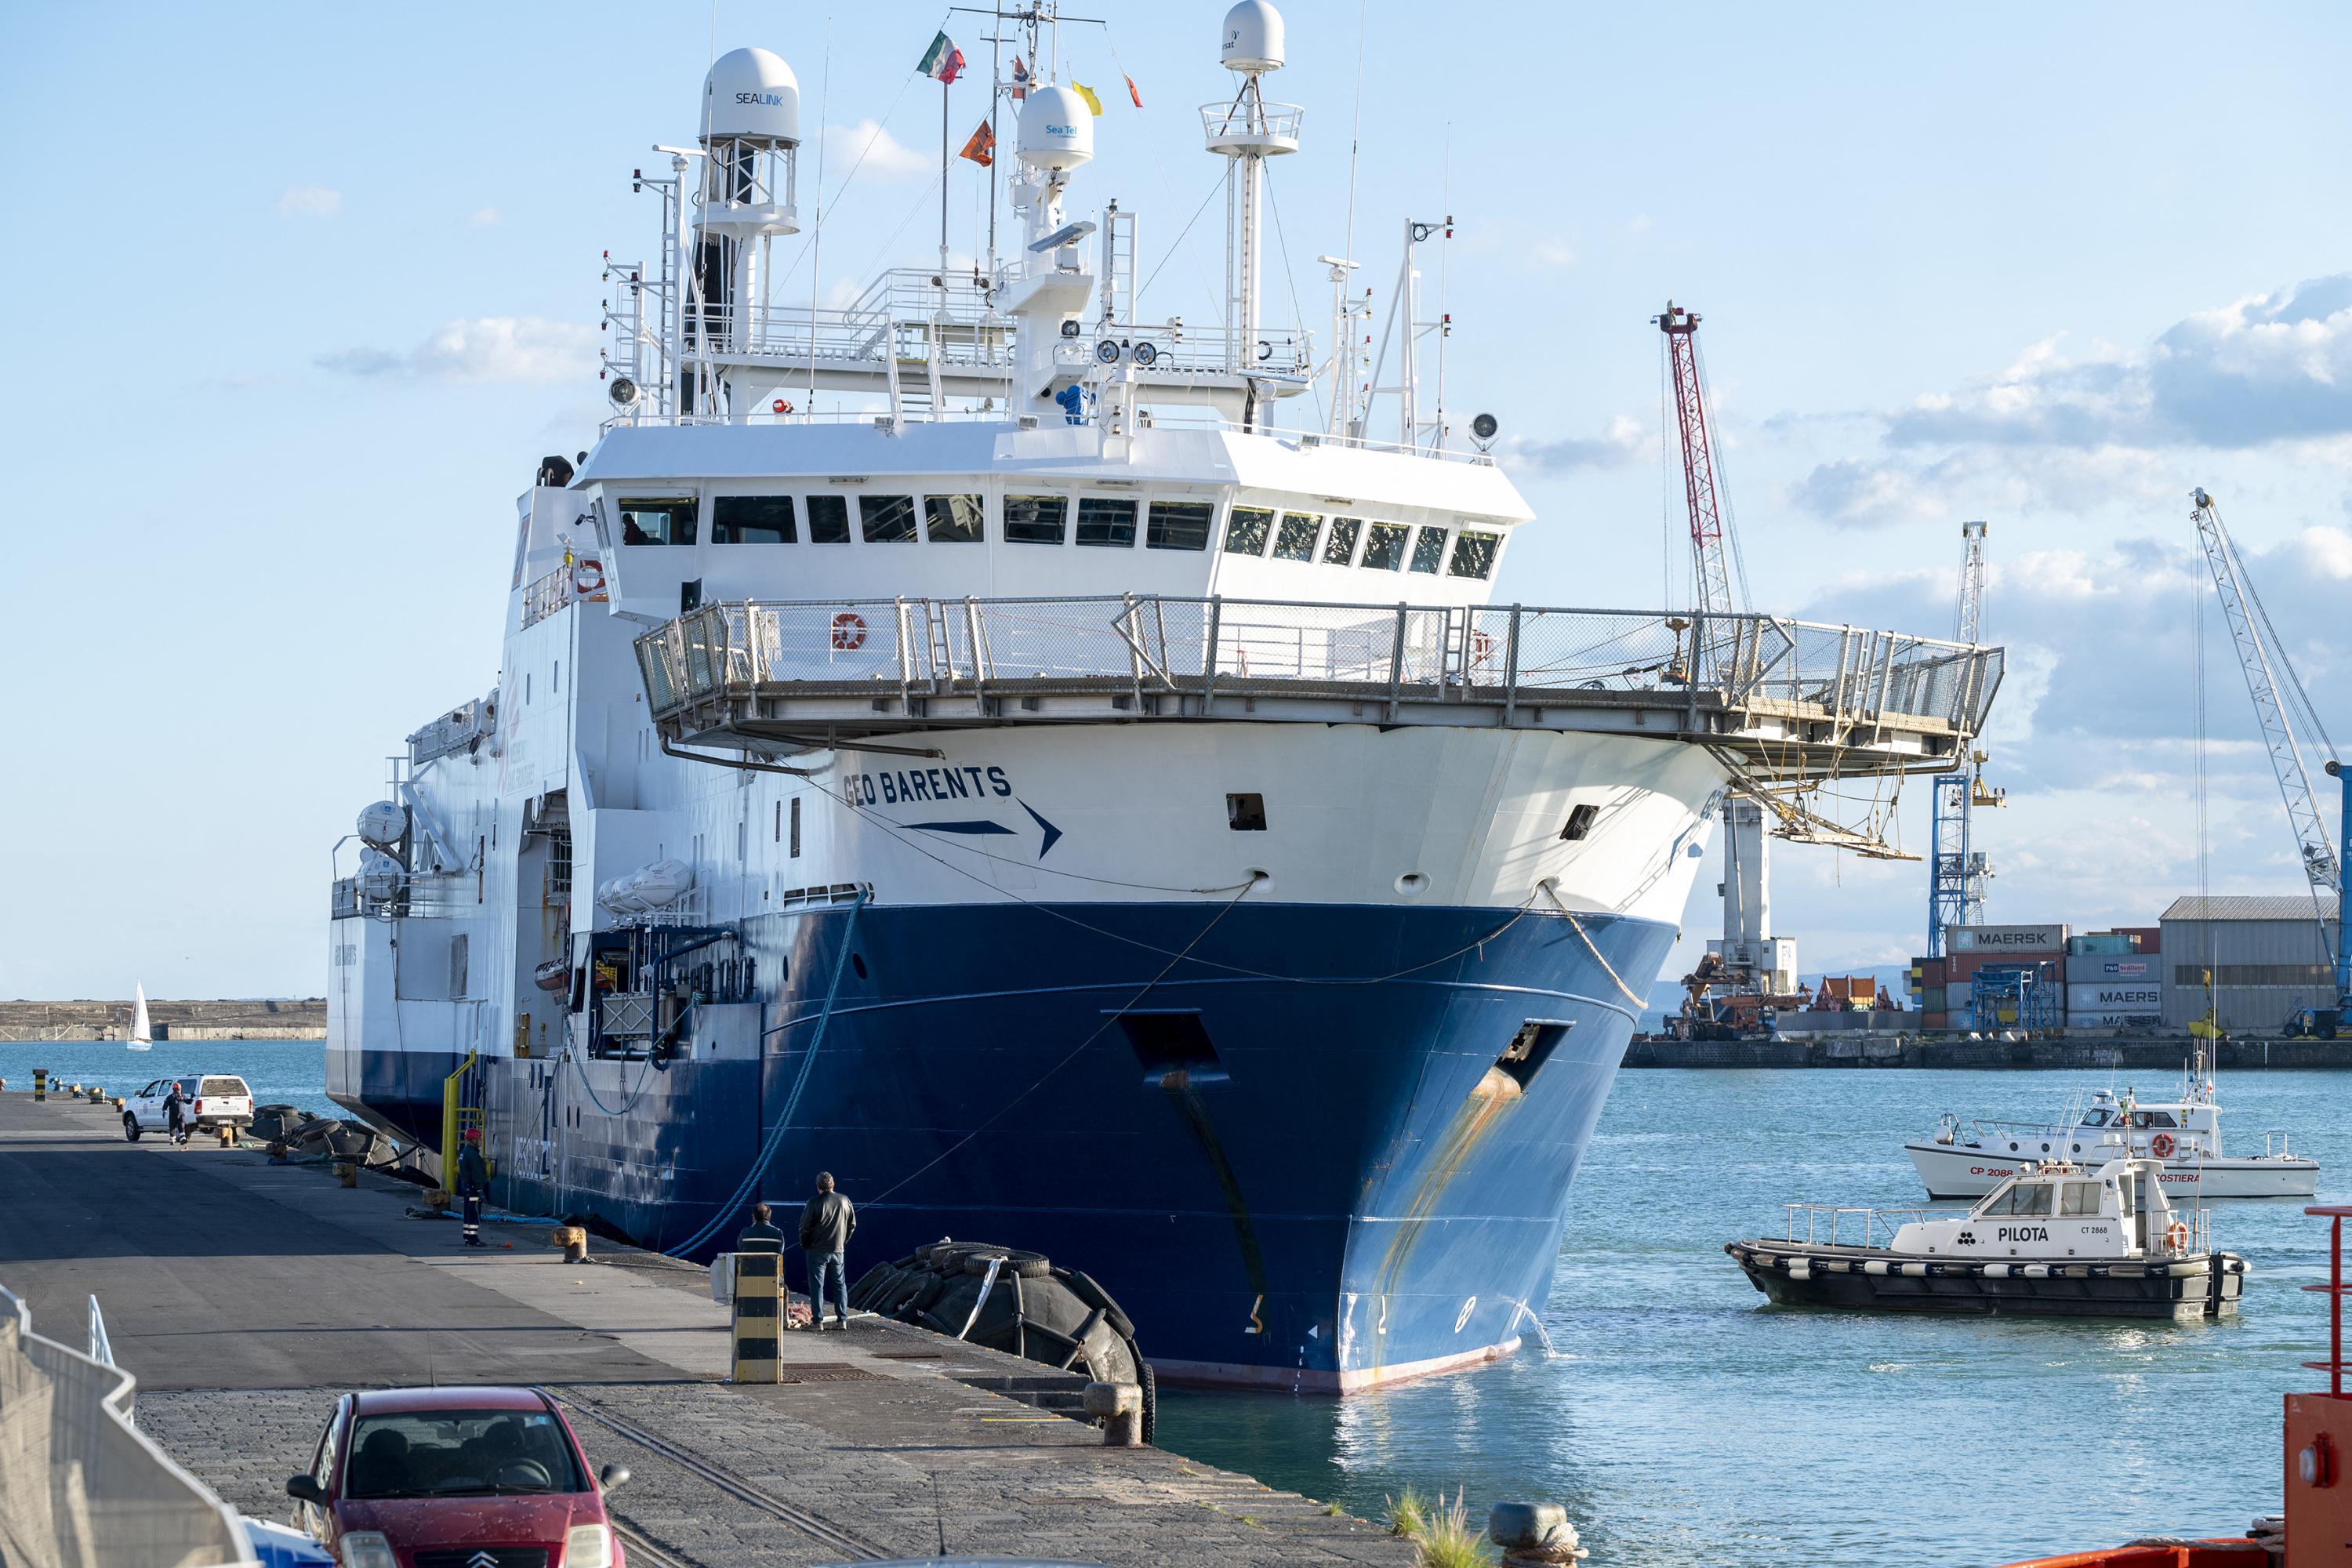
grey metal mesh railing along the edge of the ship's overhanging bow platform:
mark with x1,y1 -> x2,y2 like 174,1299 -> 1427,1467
637,595 -> 2002,746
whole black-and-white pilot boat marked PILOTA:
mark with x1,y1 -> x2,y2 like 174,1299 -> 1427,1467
1724,1156 -> 2246,1319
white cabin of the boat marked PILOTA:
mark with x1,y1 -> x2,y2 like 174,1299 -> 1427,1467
1893,1159 -> 2197,1260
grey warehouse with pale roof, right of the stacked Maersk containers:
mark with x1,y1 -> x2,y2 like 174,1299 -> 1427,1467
2161,893 -> 2336,1034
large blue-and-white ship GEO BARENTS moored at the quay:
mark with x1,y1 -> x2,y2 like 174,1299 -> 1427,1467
327,0 -> 1999,1392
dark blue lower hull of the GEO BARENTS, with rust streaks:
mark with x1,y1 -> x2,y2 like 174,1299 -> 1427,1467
329,905 -> 1675,1389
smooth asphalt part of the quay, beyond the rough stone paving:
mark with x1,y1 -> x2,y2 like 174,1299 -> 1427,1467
0,1088 -> 677,1389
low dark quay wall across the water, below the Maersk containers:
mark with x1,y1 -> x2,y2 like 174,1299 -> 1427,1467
1625,1034 -> 2352,1072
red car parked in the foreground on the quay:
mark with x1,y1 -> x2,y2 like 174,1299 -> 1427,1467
287,1389 -> 628,1568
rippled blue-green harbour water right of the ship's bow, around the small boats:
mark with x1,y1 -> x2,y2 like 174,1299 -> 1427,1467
1141,1069 -> 2352,1568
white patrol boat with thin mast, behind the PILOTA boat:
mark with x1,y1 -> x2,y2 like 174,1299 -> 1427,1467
1903,1046 -> 2319,1199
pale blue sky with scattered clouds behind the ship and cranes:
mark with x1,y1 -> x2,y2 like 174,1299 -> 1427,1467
0,0 -> 2352,996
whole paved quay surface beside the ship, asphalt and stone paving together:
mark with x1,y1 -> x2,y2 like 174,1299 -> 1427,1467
0,1088 -> 1414,1568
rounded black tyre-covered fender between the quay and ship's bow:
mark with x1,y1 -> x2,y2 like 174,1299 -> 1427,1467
849,1241 -> 1160,1443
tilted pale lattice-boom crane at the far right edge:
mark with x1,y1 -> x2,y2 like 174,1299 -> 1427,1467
2190,487 -> 2352,1034
